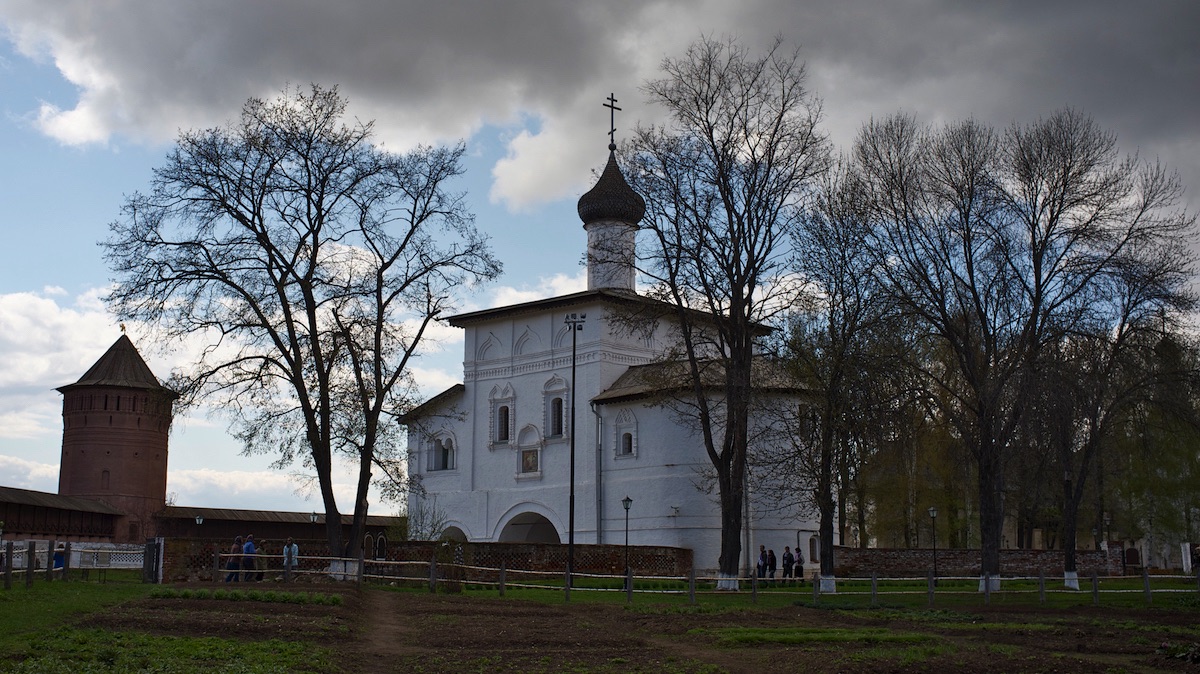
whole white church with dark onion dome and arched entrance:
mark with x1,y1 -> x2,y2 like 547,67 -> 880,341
403,139 -> 817,574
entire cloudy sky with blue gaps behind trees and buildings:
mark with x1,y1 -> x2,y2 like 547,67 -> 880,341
0,0 -> 1200,512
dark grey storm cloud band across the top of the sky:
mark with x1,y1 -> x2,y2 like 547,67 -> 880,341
0,0 -> 1200,204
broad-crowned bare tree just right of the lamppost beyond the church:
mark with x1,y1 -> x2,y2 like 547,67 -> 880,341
856,110 -> 1194,576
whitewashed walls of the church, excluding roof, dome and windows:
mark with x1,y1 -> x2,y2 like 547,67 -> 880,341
409,296 -> 816,570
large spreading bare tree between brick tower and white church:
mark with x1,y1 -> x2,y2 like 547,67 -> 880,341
103,85 -> 499,554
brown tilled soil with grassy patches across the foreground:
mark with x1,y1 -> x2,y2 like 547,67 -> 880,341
75,585 -> 1200,674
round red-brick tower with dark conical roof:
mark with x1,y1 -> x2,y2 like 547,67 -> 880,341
59,335 -> 179,542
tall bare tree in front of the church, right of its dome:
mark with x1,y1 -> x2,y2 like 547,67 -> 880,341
629,38 -> 828,585
